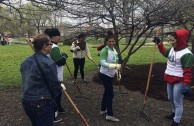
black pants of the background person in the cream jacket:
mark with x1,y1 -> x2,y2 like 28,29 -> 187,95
73,58 -> 85,80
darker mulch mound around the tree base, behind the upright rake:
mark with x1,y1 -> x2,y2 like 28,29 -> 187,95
92,63 -> 194,101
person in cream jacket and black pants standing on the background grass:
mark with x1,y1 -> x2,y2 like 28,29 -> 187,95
70,33 -> 92,82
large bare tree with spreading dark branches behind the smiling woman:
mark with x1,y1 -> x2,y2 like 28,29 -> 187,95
1,0 -> 194,68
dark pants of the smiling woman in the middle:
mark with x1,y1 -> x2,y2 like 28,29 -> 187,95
99,73 -> 114,116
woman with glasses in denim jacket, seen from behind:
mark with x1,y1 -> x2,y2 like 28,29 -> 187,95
20,34 -> 61,126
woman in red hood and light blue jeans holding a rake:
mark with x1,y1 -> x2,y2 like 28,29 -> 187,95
153,29 -> 194,126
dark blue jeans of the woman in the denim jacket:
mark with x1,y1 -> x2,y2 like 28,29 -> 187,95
22,99 -> 54,126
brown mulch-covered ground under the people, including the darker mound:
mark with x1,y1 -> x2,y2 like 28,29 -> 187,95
0,64 -> 194,126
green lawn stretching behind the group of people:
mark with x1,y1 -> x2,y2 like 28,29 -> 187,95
0,41 -> 166,87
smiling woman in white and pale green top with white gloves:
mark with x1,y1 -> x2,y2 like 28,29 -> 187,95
99,31 -> 121,122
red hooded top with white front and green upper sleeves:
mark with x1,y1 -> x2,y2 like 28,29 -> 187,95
158,29 -> 194,85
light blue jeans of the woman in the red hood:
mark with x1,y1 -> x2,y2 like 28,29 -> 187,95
167,83 -> 184,123
